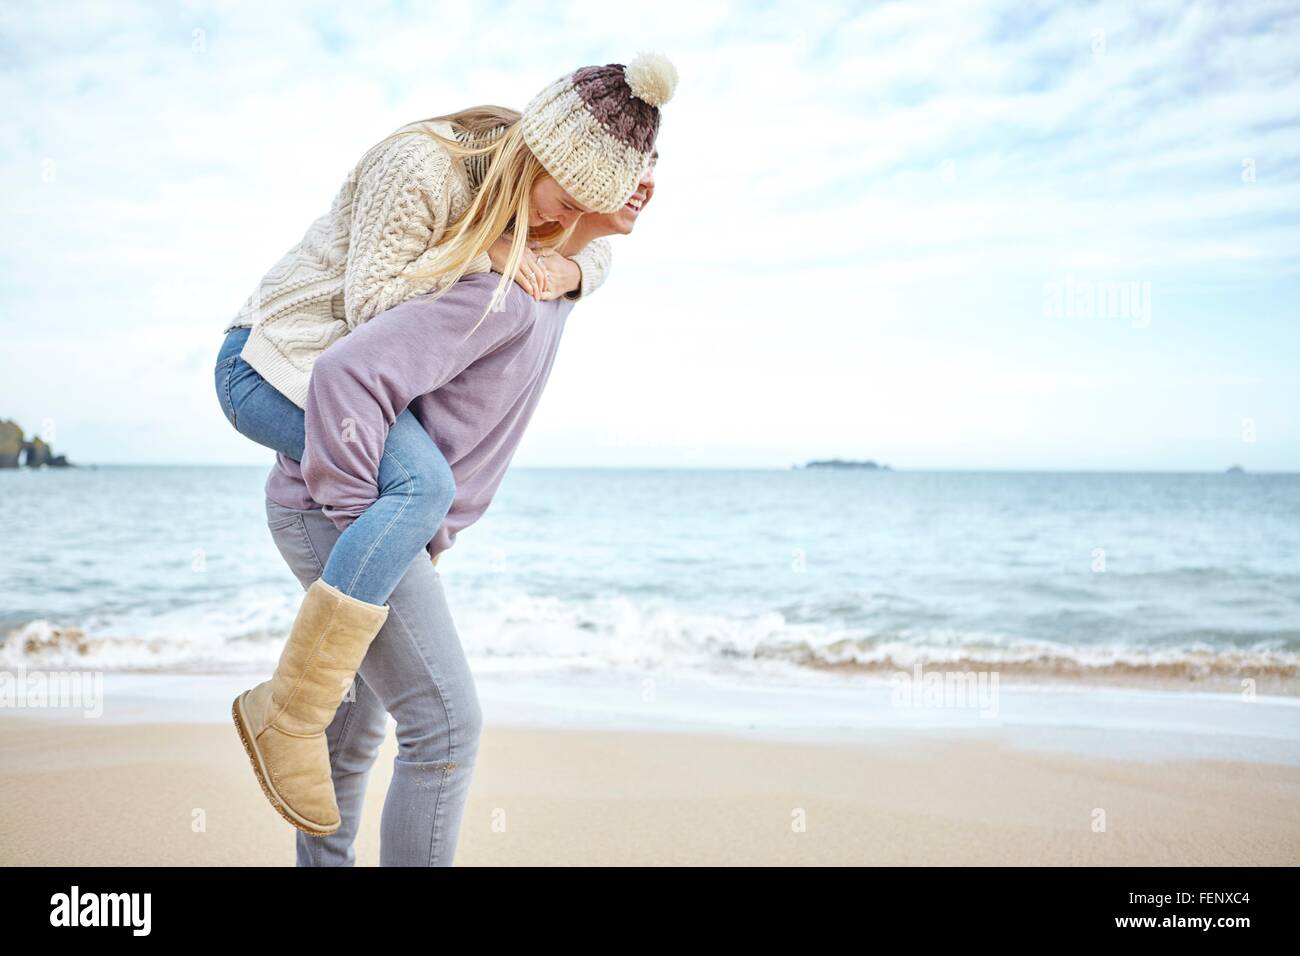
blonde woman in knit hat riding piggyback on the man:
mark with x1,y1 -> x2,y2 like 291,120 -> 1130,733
216,55 -> 677,836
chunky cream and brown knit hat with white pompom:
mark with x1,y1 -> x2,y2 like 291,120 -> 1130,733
523,53 -> 677,212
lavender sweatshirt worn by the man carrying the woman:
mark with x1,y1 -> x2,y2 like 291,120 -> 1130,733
267,273 -> 575,558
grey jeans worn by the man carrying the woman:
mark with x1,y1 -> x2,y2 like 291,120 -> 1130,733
267,498 -> 482,866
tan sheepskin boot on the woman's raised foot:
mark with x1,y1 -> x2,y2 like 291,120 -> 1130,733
231,580 -> 389,836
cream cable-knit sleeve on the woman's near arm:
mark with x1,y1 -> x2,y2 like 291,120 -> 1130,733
343,133 -> 491,329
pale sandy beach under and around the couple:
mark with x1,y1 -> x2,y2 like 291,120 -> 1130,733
0,681 -> 1300,866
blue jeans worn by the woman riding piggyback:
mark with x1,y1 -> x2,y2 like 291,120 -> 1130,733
216,329 -> 456,605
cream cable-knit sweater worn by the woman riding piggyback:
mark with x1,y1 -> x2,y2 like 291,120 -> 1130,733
225,121 -> 610,407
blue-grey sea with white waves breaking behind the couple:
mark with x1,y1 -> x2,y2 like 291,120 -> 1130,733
0,467 -> 1300,680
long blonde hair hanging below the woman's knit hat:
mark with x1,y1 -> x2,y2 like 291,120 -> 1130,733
369,105 -> 577,337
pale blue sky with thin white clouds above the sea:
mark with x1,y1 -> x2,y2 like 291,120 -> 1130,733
0,0 -> 1300,471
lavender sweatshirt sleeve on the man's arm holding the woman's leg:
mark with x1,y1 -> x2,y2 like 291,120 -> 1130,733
302,273 -> 536,529
